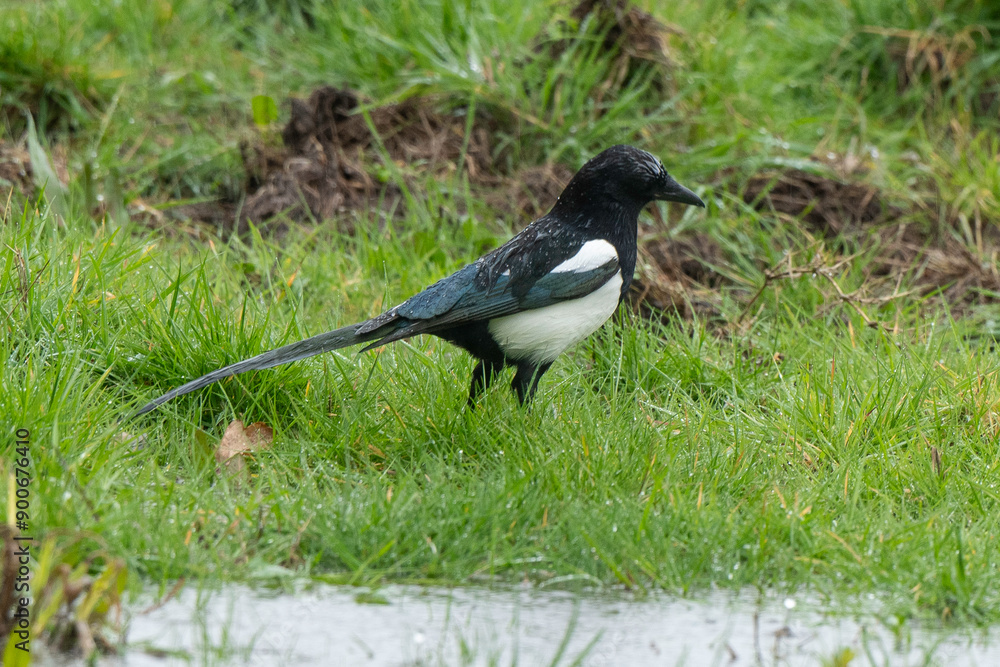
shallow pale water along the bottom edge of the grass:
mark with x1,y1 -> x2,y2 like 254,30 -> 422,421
56,586 -> 1000,667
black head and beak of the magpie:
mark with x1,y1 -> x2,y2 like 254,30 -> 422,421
564,145 -> 705,208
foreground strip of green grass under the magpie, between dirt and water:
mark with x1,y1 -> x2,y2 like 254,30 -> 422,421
2,198 -> 1000,621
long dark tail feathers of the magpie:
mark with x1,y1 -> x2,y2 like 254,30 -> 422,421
132,324 -> 386,417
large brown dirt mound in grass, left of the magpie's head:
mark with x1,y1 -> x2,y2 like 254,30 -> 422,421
239,86 -> 496,236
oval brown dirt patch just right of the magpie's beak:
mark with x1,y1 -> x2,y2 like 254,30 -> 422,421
743,169 -> 900,237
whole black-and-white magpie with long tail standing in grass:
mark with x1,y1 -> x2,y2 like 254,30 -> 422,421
135,145 -> 705,416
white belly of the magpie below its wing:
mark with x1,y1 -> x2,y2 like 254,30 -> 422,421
489,271 -> 622,364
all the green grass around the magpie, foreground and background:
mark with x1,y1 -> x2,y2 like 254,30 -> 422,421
0,0 -> 1000,652
